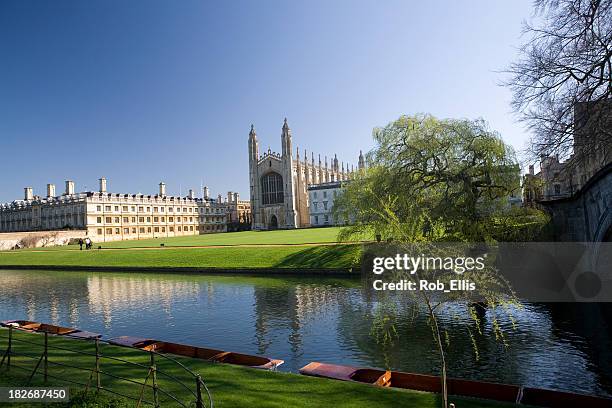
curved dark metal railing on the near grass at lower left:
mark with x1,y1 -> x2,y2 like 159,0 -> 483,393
0,327 -> 213,408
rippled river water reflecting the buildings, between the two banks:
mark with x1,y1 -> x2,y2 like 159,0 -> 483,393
0,271 -> 612,396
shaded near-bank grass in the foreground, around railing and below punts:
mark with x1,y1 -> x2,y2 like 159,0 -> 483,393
0,329 -> 514,408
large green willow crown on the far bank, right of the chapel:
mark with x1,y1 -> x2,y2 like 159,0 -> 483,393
334,115 -> 547,242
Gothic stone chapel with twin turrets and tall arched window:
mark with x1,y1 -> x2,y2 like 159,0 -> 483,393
248,119 -> 364,230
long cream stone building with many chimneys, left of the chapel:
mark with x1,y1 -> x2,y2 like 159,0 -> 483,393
0,178 -> 237,242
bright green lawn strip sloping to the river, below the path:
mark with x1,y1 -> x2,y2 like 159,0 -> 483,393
0,244 -> 361,269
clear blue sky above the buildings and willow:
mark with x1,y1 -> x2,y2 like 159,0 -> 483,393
0,0 -> 532,202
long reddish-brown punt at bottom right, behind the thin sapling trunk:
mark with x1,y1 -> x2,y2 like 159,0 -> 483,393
300,362 -> 612,408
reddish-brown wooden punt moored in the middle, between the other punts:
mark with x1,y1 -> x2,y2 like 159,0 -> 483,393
109,336 -> 284,370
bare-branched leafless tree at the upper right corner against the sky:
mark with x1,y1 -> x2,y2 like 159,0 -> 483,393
505,0 -> 612,164
